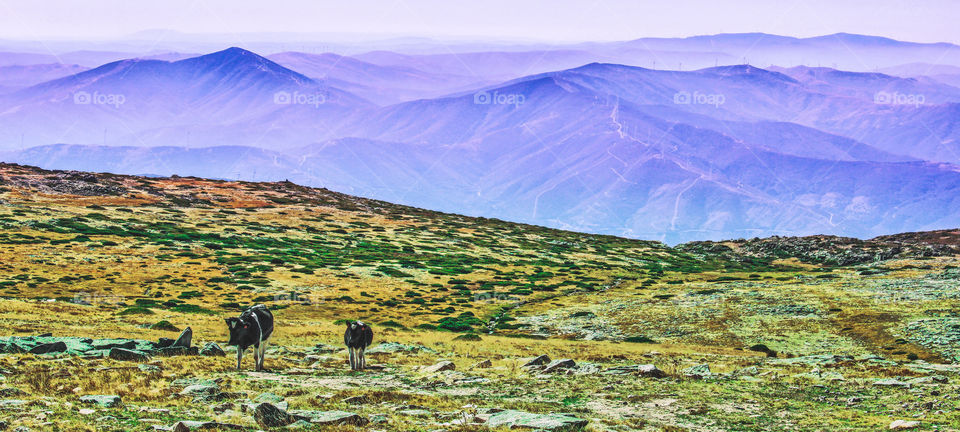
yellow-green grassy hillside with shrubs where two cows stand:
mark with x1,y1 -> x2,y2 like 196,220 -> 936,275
0,164 -> 960,431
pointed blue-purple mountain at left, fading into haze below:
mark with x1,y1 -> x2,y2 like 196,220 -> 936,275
0,48 -> 370,148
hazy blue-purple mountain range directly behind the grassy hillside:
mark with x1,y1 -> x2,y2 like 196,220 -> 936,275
0,43 -> 960,243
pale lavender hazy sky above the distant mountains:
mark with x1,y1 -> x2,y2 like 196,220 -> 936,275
0,0 -> 960,43
